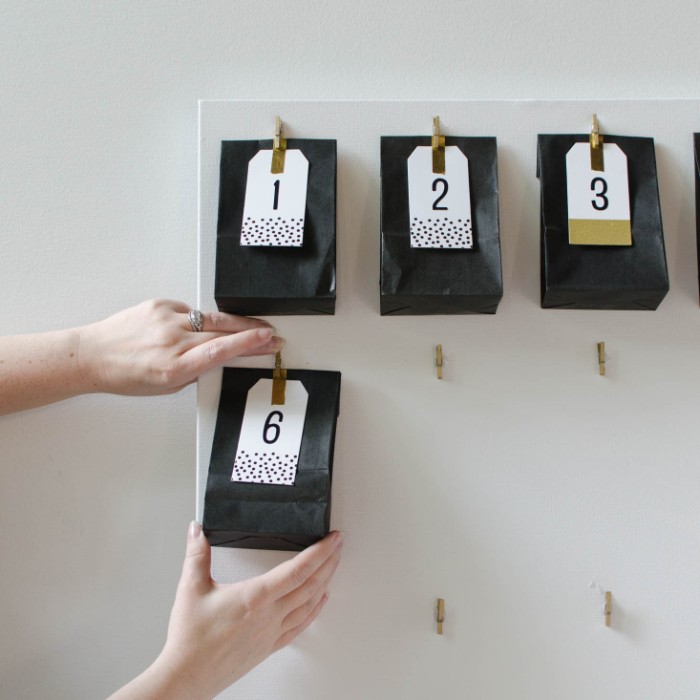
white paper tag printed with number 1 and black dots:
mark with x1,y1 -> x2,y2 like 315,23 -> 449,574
241,149 -> 309,247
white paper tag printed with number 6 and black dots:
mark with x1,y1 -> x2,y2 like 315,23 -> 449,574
231,379 -> 309,486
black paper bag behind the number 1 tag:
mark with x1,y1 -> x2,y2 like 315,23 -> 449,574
214,139 -> 337,316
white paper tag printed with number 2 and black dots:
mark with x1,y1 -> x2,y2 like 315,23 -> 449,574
408,146 -> 474,248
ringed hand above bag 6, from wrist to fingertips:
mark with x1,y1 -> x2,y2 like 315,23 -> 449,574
79,299 -> 282,395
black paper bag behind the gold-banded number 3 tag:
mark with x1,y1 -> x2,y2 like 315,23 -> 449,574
537,134 -> 669,310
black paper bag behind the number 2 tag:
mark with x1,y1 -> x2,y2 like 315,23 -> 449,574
380,136 -> 503,315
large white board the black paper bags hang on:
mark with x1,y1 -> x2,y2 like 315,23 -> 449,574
197,100 -> 700,700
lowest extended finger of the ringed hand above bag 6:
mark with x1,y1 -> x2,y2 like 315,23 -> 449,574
177,326 -> 281,384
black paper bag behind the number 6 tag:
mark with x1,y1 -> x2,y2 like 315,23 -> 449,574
203,368 -> 340,551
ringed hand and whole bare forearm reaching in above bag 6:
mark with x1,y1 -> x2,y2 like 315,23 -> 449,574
0,300 -> 282,415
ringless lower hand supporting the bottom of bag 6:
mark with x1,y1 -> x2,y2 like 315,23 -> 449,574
111,523 -> 342,700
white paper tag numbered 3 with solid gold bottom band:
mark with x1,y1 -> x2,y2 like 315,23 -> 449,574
566,143 -> 632,245
